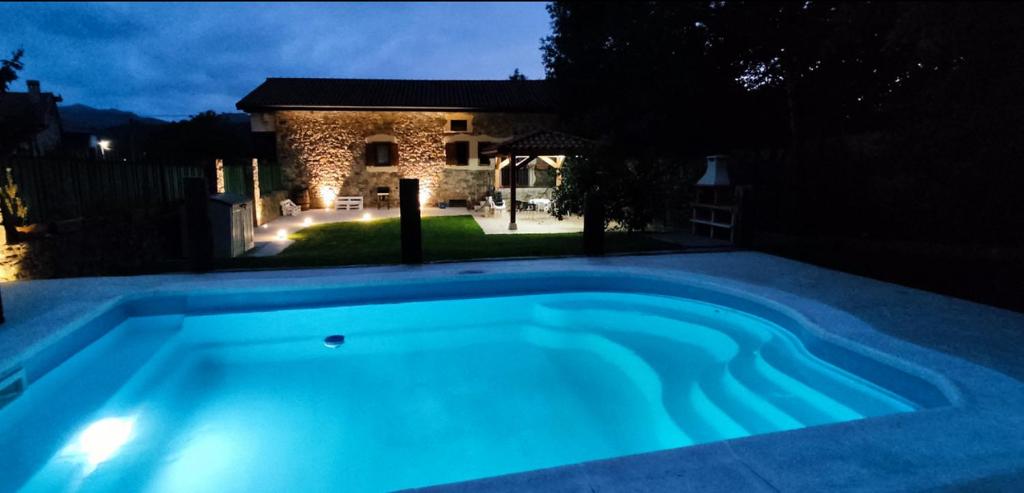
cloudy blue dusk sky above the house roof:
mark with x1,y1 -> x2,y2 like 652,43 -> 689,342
0,3 -> 550,119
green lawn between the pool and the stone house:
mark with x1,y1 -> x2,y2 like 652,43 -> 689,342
225,215 -> 675,266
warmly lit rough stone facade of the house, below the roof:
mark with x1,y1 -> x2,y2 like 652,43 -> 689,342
274,111 -> 554,207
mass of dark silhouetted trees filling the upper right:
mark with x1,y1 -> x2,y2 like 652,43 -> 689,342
542,0 -> 1024,244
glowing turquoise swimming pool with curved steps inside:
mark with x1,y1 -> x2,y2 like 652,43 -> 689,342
0,272 -> 947,491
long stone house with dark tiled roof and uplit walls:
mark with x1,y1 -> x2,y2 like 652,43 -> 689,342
237,78 -> 561,207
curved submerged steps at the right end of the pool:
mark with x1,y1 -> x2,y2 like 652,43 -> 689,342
536,297 -> 913,443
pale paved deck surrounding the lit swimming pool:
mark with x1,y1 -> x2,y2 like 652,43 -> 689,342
0,252 -> 1024,492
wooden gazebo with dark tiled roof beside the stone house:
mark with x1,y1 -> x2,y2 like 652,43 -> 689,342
482,130 -> 597,231
